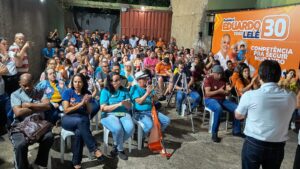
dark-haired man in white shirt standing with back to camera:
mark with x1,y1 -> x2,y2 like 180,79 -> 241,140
235,60 -> 296,169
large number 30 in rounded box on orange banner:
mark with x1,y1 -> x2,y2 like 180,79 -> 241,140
261,15 -> 290,40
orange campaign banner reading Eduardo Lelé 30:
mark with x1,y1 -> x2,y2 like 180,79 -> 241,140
212,5 -> 300,72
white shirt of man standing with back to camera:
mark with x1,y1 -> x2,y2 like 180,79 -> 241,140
235,83 -> 296,142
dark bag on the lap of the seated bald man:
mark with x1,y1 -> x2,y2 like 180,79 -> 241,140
10,113 -> 52,144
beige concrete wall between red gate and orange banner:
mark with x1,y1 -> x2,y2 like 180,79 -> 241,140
171,0 -> 210,51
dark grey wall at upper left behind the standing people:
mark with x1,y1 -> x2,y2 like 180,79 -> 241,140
0,0 -> 63,78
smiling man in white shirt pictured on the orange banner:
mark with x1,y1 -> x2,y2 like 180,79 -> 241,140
214,34 -> 231,70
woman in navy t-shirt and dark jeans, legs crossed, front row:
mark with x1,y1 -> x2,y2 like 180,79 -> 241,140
61,74 -> 104,169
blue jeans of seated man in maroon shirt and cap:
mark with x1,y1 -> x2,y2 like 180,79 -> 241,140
205,98 -> 241,134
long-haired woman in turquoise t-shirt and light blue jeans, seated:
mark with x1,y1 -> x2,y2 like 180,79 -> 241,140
100,72 -> 134,160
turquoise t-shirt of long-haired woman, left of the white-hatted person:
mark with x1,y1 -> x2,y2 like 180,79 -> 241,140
100,88 -> 129,113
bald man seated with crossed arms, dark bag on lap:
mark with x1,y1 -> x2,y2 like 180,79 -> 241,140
11,73 -> 54,169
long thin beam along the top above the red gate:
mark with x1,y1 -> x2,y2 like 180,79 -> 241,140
60,0 -> 171,11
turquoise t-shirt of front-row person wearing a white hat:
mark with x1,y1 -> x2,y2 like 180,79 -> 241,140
130,85 -> 154,111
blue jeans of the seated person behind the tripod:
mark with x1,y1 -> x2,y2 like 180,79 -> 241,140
176,91 -> 201,112
